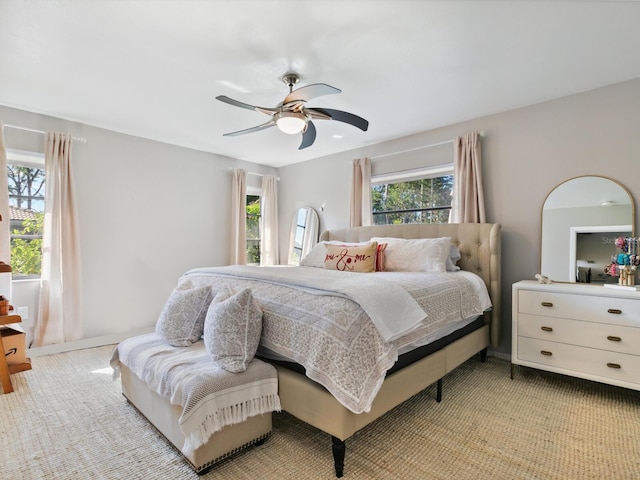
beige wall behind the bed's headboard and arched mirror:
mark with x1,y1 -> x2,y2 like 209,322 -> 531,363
280,79 -> 640,353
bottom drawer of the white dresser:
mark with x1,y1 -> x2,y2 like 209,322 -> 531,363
517,337 -> 640,387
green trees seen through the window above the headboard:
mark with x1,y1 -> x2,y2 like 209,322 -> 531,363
371,175 -> 453,225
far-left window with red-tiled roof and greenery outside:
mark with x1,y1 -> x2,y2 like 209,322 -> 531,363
7,150 -> 45,278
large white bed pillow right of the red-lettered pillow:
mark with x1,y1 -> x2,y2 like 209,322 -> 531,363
371,237 -> 451,273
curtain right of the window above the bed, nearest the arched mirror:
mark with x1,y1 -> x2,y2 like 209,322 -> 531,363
449,132 -> 485,223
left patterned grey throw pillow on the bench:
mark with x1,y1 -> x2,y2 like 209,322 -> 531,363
156,286 -> 213,347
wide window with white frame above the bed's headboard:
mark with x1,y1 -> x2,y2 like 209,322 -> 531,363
371,164 -> 453,225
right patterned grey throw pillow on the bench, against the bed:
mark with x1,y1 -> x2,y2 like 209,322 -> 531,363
204,287 -> 262,373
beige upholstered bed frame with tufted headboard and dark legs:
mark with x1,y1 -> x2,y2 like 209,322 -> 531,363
276,223 -> 501,477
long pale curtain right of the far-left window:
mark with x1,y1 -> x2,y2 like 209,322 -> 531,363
33,132 -> 83,346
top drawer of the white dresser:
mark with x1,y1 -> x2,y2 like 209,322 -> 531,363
518,287 -> 640,327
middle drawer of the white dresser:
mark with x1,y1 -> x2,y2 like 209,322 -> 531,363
518,314 -> 640,354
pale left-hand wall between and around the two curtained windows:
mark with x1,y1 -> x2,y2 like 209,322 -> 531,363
0,106 -> 275,346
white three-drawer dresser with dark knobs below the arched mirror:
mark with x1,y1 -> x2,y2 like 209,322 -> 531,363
511,281 -> 640,390
